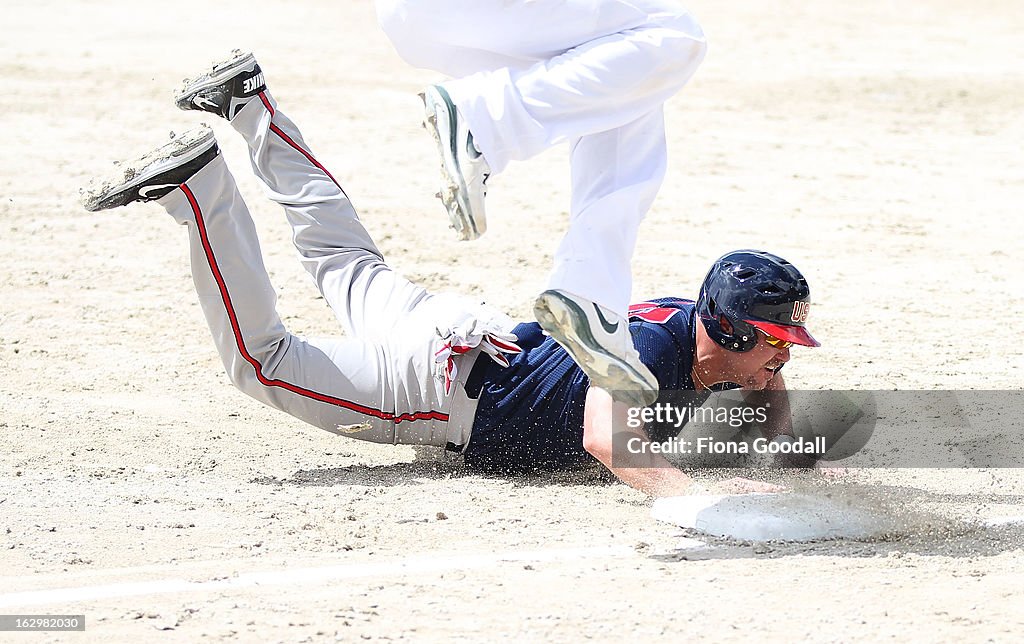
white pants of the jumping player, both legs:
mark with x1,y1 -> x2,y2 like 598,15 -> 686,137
377,0 -> 706,316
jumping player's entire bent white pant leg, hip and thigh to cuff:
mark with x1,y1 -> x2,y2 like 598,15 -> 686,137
378,0 -> 707,173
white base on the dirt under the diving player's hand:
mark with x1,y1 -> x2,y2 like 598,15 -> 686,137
651,493 -> 893,542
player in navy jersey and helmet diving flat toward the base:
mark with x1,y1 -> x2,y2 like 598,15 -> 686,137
84,53 -> 817,495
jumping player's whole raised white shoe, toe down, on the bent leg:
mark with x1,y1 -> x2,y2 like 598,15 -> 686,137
420,85 -> 490,242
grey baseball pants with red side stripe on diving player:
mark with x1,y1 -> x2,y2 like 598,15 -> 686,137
160,92 -> 487,445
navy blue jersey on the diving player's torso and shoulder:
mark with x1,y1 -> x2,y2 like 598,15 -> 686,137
464,298 -> 694,472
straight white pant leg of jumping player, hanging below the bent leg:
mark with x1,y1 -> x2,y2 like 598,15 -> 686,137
548,108 -> 668,317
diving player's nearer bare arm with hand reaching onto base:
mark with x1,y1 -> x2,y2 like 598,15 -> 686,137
583,387 -> 781,497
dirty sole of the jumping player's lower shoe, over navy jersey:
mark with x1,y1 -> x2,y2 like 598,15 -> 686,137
534,291 -> 658,406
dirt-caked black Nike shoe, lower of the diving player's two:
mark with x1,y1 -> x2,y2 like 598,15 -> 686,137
82,125 -> 220,212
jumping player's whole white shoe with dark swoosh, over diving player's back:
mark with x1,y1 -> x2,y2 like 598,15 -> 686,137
534,290 -> 658,406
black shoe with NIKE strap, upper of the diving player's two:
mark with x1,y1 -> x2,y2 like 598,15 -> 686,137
174,49 -> 266,121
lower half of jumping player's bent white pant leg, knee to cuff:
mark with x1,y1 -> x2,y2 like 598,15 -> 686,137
444,15 -> 706,173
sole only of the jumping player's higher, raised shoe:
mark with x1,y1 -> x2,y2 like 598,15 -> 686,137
420,86 -> 487,242
